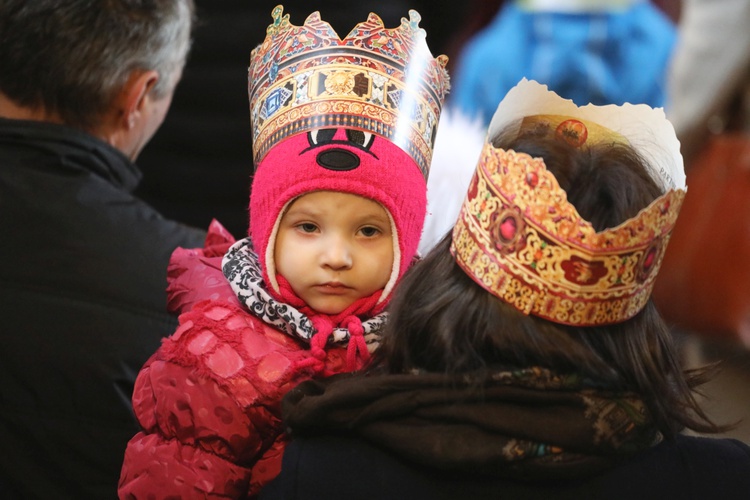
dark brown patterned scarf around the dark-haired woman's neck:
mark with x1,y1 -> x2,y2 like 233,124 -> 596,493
283,368 -> 661,480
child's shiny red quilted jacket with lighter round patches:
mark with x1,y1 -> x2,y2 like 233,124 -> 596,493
118,225 -> 360,499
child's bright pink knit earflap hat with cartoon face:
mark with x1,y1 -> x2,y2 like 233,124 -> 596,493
250,128 -> 427,302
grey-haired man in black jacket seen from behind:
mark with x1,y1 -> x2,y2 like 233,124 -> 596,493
0,0 -> 204,499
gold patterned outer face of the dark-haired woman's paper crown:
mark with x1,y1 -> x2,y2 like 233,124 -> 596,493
451,144 -> 685,326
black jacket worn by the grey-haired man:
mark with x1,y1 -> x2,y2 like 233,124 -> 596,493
0,119 -> 204,499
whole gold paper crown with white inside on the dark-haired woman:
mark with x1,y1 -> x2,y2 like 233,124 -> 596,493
451,80 -> 686,326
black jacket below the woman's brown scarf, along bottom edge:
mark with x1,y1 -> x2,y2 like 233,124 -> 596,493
260,435 -> 750,500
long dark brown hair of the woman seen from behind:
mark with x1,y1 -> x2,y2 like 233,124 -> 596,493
372,132 -> 725,438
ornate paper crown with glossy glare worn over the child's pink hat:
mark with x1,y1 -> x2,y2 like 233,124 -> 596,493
248,5 -> 449,177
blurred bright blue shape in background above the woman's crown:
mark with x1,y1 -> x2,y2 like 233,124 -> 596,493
451,1 -> 676,122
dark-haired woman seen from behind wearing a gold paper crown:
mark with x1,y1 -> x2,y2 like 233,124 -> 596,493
263,81 -> 750,500
